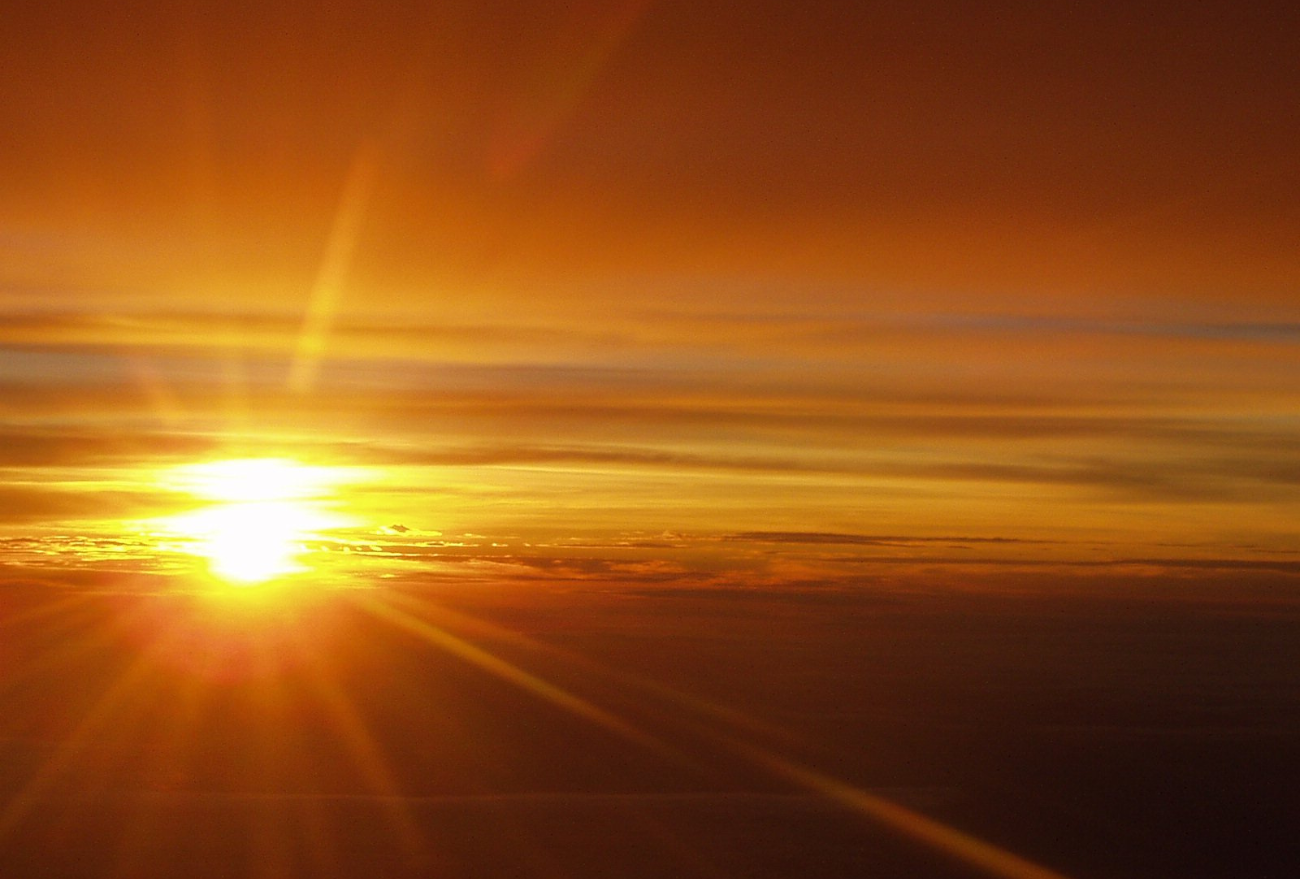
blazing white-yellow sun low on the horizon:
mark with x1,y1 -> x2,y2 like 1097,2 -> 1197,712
161,458 -> 350,586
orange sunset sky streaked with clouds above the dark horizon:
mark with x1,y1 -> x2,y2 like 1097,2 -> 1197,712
0,0 -> 1300,585
